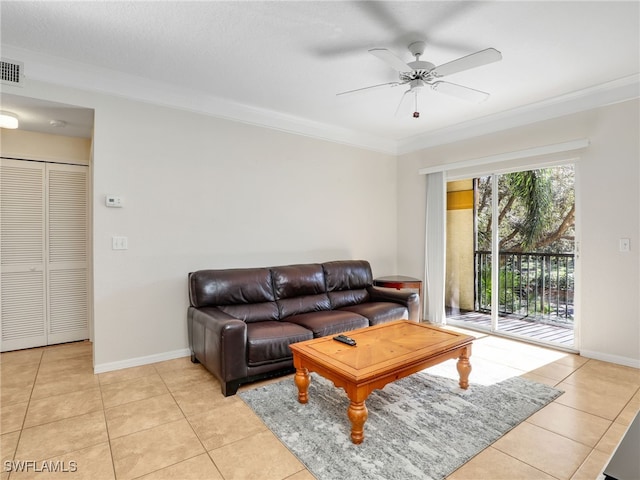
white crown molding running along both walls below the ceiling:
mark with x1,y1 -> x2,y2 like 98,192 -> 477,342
2,45 -> 640,155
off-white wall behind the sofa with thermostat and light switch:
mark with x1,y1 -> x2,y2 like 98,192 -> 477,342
11,82 -> 397,371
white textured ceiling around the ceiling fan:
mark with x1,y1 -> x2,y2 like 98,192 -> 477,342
0,0 -> 640,151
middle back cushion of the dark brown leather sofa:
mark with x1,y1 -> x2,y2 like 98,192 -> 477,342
271,263 -> 331,319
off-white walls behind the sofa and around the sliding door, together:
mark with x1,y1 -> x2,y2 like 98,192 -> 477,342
3,81 -> 640,370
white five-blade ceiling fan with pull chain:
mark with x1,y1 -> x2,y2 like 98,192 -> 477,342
338,42 -> 502,118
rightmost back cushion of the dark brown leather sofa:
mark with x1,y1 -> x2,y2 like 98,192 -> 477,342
322,260 -> 373,308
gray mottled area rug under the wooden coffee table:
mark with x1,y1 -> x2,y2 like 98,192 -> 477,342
239,371 -> 562,480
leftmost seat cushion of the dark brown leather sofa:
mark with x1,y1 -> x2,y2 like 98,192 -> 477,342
247,321 -> 313,367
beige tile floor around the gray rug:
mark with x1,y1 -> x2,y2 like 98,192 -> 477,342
0,333 -> 640,480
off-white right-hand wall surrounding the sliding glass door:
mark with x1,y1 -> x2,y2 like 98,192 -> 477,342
398,100 -> 640,367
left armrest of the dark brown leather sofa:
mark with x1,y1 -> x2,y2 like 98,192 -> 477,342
188,307 -> 247,383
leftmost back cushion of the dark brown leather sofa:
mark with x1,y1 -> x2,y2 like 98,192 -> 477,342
189,268 -> 278,323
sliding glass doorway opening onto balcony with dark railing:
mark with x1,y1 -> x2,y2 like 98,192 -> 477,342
445,165 -> 576,349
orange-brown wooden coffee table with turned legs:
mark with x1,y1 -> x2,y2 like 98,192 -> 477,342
290,320 -> 474,444
